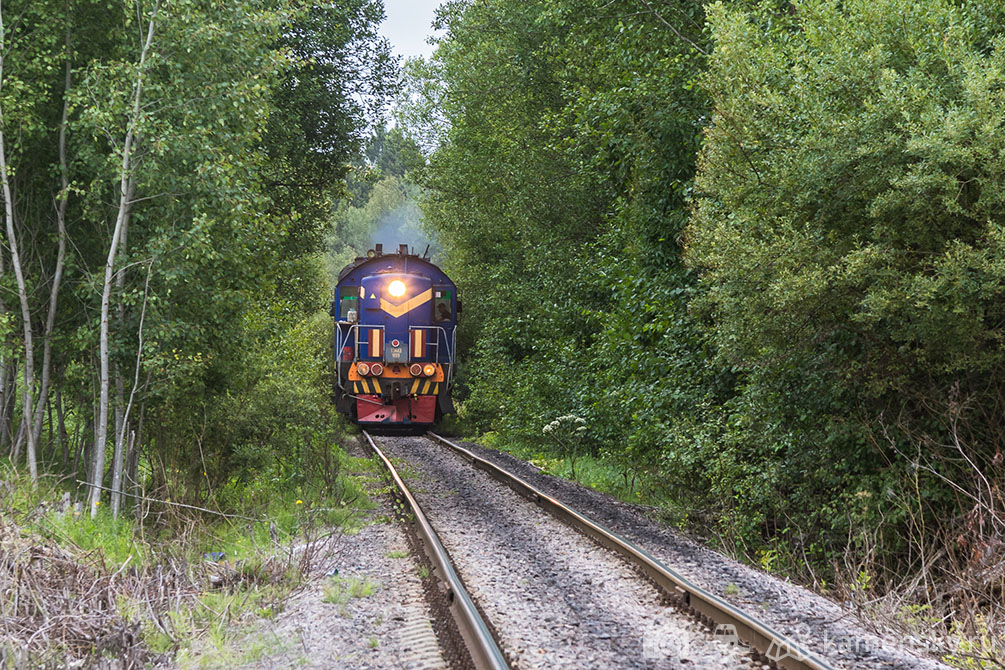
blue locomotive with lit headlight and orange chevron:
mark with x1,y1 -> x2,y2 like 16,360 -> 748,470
331,244 -> 461,432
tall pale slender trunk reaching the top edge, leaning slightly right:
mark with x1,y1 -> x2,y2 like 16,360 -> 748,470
88,3 -> 157,518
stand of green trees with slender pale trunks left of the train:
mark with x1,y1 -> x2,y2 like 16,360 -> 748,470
0,0 -> 396,515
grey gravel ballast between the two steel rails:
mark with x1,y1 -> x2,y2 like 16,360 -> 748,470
378,437 -> 751,669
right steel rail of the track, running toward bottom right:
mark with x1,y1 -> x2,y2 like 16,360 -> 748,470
427,432 -> 835,670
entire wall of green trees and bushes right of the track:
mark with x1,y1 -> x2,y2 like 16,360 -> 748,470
412,0 -> 1005,650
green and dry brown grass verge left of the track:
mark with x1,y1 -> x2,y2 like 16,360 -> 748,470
0,448 -> 370,669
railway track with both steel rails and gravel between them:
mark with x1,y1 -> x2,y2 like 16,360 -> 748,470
364,433 -> 832,670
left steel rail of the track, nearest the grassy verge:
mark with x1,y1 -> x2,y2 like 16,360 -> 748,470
363,431 -> 510,670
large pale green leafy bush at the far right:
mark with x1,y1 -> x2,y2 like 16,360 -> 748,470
687,0 -> 1005,578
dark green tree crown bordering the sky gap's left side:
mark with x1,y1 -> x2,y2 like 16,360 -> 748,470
262,0 -> 395,244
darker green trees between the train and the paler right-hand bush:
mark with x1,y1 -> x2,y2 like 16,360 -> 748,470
414,0 -> 715,522
